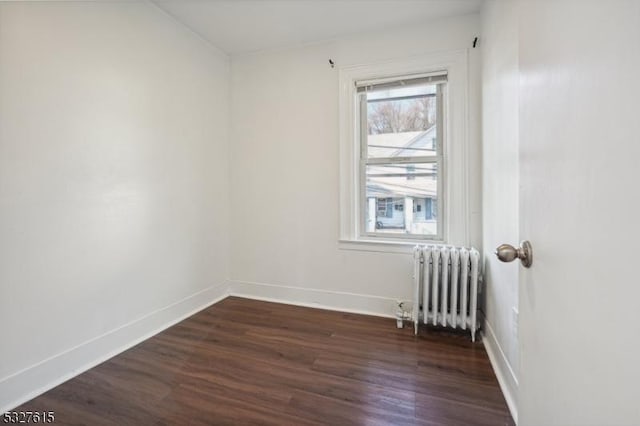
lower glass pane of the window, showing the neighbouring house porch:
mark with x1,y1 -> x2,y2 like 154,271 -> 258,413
365,163 -> 438,235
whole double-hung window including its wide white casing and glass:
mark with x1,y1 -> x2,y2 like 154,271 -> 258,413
339,50 -> 470,251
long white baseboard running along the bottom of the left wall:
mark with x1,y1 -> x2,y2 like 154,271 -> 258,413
0,282 -> 229,413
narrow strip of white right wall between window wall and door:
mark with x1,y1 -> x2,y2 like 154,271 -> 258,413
480,0 -> 520,417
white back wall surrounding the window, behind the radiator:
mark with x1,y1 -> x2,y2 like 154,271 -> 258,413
231,15 -> 481,315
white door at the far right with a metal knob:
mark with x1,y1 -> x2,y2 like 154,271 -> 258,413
516,0 -> 640,425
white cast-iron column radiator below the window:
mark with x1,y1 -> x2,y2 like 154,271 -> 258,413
412,245 -> 480,342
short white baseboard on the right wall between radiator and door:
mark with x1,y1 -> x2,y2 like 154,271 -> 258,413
482,320 -> 518,424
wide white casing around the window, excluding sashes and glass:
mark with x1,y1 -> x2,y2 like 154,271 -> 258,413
339,50 -> 470,251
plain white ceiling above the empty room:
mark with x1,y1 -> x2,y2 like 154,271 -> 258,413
154,0 -> 482,54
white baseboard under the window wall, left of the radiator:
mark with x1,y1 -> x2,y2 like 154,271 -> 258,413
229,281 -> 396,318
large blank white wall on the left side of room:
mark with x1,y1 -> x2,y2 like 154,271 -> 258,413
0,2 -> 229,411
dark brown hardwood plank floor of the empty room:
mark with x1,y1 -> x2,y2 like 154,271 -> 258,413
16,297 -> 513,425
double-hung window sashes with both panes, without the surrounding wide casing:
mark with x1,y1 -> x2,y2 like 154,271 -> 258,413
355,71 -> 447,240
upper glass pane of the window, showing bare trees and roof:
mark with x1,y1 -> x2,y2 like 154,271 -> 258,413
366,84 -> 437,158
